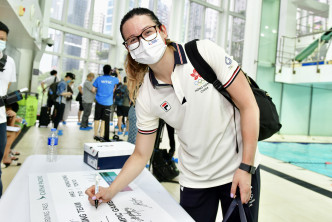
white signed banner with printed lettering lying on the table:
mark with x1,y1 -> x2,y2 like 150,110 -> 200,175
30,170 -> 175,222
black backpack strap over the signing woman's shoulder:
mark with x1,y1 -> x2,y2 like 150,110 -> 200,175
184,39 -> 236,107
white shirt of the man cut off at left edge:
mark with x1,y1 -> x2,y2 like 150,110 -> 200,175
0,55 -> 16,123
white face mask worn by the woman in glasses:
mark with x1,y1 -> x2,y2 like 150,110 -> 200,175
129,33 -> 167,65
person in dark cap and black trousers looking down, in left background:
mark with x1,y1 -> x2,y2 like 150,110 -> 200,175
53,72 -> 75,131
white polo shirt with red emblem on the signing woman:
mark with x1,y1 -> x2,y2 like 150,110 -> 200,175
136,40 -> 259,188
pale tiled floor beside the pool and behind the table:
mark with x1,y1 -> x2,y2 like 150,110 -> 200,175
2,120 -> 332,222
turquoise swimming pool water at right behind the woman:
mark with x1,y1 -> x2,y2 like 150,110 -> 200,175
258,142 -> 332,177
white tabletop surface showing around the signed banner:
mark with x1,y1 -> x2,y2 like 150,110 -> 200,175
0,155 -> 193,222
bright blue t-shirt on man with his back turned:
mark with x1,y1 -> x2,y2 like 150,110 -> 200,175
93,75 -> 119,106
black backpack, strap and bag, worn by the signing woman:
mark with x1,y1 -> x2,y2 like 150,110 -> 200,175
185,39 -> 282,141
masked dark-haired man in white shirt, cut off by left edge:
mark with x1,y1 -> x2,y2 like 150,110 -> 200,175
0,21 -> 16,198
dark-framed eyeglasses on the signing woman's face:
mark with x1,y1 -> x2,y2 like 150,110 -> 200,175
122,25 -> 157,51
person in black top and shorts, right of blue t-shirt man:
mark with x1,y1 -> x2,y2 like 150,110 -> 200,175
114,76 -> 130,135
